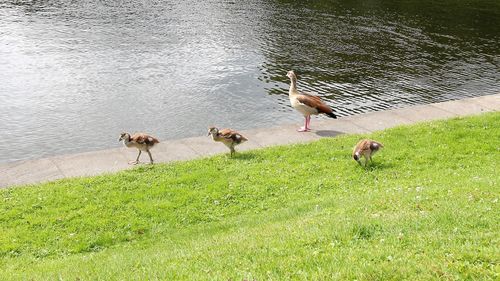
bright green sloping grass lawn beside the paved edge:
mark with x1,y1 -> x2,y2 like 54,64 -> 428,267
0,113 -> 500,280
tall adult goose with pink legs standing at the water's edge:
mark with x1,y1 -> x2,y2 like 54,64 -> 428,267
286,70 -> 337,132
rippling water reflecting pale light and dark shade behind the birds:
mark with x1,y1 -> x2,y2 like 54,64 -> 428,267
0,0 -> 500,162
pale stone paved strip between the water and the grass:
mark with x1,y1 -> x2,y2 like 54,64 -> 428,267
0,94 -> 500,187
